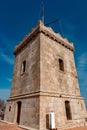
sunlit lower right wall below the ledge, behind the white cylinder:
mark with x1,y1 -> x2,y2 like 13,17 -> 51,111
40,94 -> 86,130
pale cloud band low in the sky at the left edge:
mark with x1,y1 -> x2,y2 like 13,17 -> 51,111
0,89 -> 10,101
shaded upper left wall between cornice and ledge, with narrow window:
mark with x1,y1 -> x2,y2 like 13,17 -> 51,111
11,36 -> 40,97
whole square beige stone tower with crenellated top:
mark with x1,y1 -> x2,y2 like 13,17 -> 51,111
5,22 -> 86,130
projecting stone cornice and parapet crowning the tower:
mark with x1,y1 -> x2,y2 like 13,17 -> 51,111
14,21 -> 74,55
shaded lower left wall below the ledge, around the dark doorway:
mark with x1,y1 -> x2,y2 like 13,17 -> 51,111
4,97 -> 40,129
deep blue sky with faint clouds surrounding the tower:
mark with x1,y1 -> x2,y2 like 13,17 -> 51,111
0,0 -> 87,106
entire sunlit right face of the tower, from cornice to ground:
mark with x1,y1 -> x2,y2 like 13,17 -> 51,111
40,33 -> 86,130
